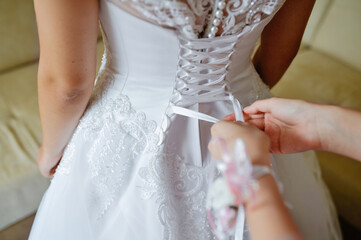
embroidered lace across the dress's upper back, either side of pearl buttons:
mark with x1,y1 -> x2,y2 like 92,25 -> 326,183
111,0 -> 285,38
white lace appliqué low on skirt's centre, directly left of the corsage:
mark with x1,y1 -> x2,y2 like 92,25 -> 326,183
139,149 -> 214,240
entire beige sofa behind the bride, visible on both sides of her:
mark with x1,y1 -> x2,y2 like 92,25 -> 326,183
0,0 -> 361,235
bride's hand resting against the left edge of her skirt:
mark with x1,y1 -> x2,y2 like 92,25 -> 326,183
38,146 -> 63,178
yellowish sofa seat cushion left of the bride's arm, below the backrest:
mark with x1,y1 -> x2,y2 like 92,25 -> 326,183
0,64 -> 48,229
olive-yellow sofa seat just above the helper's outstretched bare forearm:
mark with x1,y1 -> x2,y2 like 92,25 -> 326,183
272,50 -> 361,110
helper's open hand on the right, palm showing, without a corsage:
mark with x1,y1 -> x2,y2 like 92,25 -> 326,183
225,98 -> 321,153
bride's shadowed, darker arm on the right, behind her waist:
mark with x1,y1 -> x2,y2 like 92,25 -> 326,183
253,0 -> 315,87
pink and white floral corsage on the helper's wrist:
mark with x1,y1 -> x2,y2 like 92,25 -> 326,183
207,138 -> 272,239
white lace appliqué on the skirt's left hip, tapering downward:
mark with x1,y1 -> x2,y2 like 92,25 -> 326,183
79,95 -> 159,219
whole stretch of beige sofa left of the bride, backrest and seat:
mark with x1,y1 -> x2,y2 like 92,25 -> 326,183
0,0 -> 48,229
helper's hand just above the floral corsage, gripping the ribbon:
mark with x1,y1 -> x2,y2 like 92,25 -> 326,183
208,121 -> 270,165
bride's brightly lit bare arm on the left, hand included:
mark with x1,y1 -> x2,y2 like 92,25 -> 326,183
34,0 -> 98,177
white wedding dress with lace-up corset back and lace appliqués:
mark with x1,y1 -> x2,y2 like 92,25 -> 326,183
30,0 -> 341,240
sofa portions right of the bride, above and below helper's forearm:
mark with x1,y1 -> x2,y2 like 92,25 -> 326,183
272,0 -> 361,233
